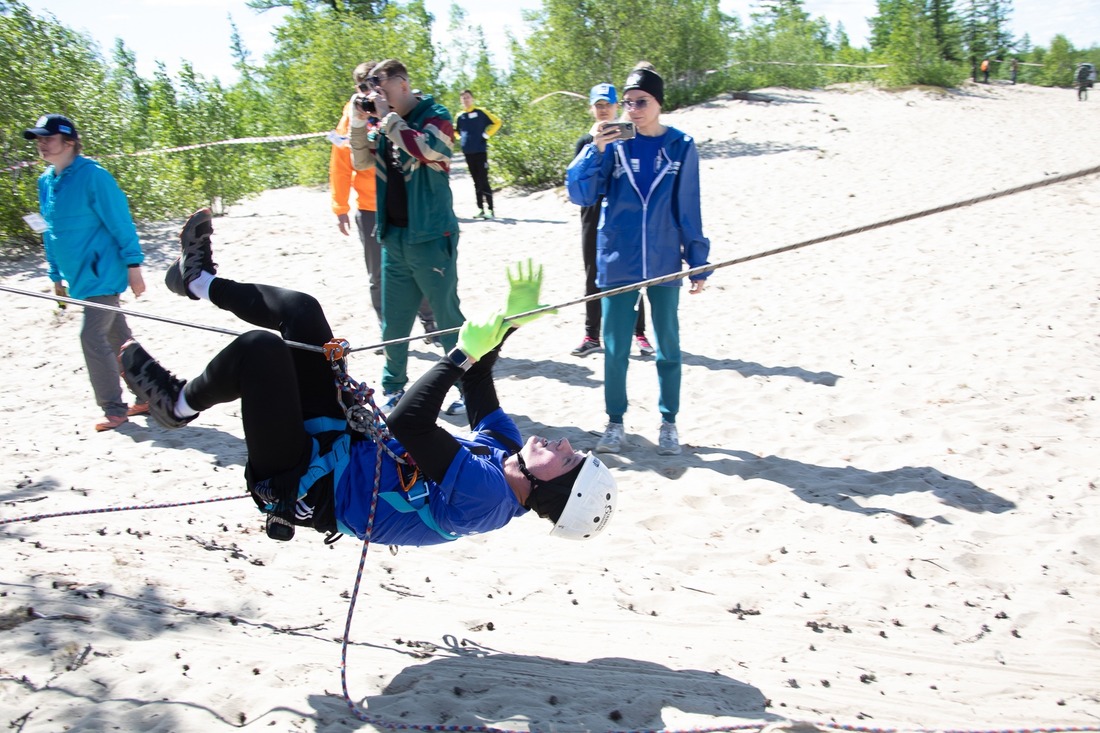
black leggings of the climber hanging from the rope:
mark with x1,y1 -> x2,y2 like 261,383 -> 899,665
184,277 -> 344,481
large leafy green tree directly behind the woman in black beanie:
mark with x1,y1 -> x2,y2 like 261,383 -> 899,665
493,0 -> 736,186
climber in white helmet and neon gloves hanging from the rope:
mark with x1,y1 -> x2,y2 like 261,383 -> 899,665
121,209 -> 616,546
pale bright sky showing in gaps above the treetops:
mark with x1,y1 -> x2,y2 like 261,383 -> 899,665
17,0 -> 1100,81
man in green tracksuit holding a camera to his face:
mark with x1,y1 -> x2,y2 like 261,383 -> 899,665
350,58 -> 465,415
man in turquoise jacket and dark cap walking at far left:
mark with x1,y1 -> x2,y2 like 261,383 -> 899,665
23,114 -> 149,431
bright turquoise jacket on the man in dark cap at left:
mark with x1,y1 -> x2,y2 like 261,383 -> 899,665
39,155 -> 145,299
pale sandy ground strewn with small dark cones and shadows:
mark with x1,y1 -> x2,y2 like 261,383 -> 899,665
0,81 -> 1100,733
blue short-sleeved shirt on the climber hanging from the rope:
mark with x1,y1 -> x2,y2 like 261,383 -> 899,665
333,407 -> 528,546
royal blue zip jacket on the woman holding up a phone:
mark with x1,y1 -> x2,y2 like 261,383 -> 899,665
565,128 -> 711,288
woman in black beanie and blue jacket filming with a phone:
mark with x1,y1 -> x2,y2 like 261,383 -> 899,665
565,68 -> 711,456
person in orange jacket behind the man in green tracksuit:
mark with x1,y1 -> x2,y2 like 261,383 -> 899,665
329,62 -> 438,342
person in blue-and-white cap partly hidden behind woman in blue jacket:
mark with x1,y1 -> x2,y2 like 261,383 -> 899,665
571,83 -> 653,357
